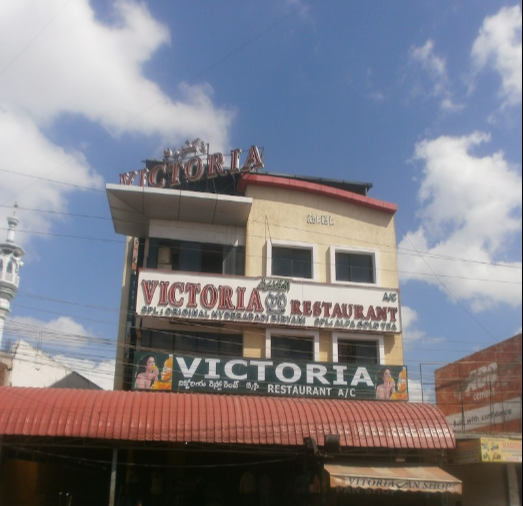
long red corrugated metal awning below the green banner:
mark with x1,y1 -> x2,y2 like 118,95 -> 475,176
0,387 -> 456,449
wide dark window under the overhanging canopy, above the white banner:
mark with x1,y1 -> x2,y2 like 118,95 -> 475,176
148,239 -> 245,276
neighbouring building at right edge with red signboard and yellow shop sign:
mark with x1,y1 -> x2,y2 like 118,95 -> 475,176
436,334 -> 523,506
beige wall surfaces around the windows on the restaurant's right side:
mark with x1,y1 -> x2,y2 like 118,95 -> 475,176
246,186 -> 404,365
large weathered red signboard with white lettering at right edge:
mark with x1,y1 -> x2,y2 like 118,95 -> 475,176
436,334 -> 522,433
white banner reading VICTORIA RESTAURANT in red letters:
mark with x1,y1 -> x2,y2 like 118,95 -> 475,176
137,270 -> 401,334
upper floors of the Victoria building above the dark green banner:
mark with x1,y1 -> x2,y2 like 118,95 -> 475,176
107,142 -> 403,390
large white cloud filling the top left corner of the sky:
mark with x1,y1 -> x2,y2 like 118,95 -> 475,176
0,0 -> 232,148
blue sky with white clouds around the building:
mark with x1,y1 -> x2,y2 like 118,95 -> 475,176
0,0 -> 522,390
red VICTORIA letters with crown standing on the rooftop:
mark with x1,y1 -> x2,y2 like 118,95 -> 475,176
120,139 -> 264,188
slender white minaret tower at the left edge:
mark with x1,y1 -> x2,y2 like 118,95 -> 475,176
0,205 -> 25,351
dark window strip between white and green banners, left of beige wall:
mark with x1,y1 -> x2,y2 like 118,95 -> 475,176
142,330 -> 243,357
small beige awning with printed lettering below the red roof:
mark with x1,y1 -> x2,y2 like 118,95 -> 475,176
325,465 -> 463,495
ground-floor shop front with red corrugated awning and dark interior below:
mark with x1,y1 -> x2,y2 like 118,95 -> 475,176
0,388 -> 460,506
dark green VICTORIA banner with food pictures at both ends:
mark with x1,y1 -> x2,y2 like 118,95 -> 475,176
134,353 -> 409,401
